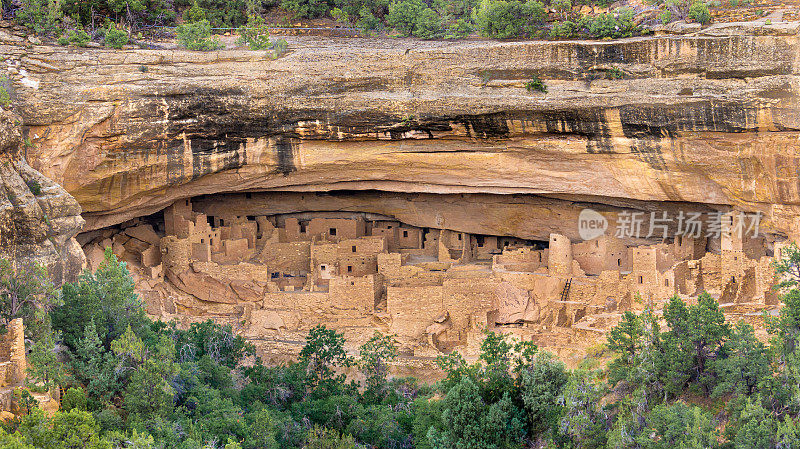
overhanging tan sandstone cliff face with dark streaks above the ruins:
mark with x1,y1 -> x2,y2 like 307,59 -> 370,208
0,27 -> 800,239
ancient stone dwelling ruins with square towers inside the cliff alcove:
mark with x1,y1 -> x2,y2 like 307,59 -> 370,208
78,192 -> 784,365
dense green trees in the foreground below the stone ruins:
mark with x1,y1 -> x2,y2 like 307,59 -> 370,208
0,246 -> 800,449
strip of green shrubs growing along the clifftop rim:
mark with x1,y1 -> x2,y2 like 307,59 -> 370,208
9,0 -> 711,43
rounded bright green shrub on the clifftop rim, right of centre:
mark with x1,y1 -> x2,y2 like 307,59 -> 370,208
473,0 -> 545,39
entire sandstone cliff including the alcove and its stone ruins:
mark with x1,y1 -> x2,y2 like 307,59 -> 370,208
0,25 -> 800,366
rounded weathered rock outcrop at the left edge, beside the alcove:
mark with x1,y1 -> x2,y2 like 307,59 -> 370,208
0,111 -> 85,285
